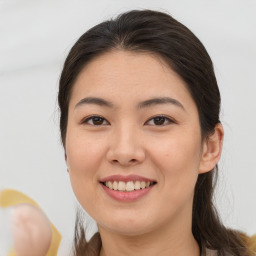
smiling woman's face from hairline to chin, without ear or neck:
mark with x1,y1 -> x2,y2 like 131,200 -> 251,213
66,51 -> 210,235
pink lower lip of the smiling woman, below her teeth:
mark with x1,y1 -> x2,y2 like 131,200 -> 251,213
100,183 -> 154,202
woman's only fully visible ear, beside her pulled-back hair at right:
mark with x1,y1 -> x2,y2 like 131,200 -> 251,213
199,123 -> 224,173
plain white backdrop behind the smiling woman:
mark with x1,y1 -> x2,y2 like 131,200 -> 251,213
0,0 -> 256,255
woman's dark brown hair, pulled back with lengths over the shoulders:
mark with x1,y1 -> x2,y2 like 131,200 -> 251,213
58,10 -> 253,256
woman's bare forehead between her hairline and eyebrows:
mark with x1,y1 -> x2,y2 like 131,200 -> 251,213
70,50 -> 193,109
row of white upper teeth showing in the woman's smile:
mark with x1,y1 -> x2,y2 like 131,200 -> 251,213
104,180 -> 151,191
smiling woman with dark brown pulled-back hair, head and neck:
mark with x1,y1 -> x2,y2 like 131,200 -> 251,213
58,10 -> 254,256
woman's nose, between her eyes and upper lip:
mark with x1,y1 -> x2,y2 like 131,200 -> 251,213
107,124 -> 145,167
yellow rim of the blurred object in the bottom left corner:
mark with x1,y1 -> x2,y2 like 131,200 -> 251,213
0,189 -> 61,256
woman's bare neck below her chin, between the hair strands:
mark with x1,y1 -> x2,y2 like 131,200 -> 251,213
99,218 -> 200,256
